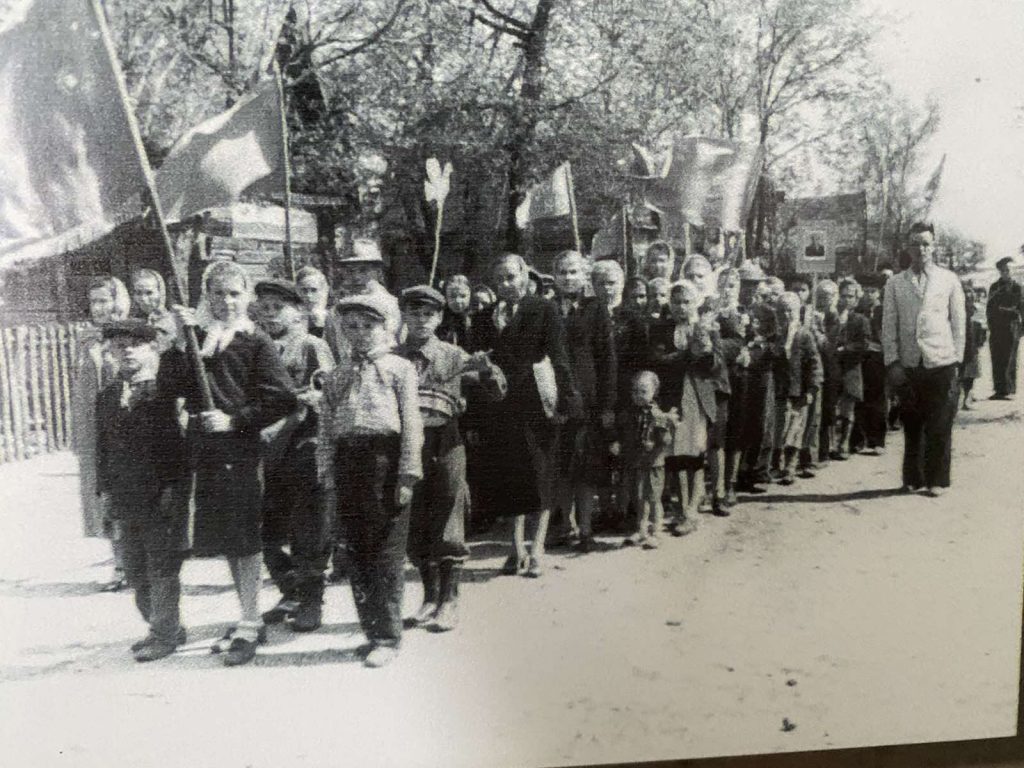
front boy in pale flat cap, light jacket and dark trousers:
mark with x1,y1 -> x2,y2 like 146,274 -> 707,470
317,294 -> 423,667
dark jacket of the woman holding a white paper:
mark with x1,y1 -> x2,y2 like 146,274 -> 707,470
469,296 -> 583,425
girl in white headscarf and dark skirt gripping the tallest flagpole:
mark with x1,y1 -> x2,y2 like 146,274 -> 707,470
160,261 -> 297,666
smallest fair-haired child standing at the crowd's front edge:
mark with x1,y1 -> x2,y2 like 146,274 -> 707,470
609,371 -> 673,549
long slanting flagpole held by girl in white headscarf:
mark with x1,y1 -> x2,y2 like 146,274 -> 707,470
89,0 -> 216,411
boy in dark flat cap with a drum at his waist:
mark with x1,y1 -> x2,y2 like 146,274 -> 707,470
395,286 -> 508,632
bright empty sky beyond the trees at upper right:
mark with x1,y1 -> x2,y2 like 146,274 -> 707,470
869,0 -> 1024,264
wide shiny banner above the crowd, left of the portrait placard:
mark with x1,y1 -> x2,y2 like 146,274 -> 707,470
634,136 -> 763,231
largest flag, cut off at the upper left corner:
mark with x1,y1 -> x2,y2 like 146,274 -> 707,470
0,0 -> 145,263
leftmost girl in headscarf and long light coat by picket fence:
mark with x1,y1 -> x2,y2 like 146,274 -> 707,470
71,275 -> 130,592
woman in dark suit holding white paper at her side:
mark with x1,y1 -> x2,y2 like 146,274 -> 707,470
470,254 -> 582,578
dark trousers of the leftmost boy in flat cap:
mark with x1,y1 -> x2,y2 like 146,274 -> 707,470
122,482 -> 188,643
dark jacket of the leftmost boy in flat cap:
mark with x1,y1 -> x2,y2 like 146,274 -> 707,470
96,380 -> 188,522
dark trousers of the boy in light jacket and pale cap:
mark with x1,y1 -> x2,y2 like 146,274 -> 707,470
335,435 -> 410,647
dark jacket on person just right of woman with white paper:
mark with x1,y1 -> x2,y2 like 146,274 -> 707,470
556,297 -> 618,415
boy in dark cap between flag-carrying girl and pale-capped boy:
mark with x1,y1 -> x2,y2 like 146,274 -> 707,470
256,280 -> 334,632
